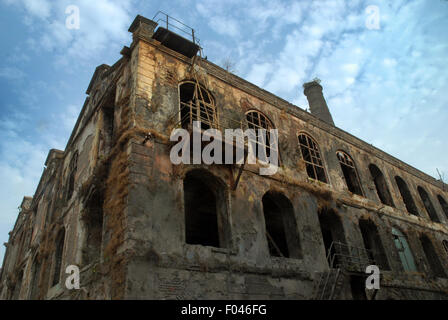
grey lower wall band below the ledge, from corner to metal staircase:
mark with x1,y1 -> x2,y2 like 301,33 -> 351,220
126,263 -> 313,300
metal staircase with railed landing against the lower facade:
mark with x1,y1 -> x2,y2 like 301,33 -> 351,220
312,242 -> 375,300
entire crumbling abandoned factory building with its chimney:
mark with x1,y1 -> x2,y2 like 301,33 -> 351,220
0,16 -> 448,299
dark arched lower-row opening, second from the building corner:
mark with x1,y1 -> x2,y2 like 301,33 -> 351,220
262,192 -> 302,259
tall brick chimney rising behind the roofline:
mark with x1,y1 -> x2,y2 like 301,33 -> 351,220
303,80 -> 334,126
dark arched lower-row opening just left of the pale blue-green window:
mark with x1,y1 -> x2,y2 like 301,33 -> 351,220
359,220 -> 390,270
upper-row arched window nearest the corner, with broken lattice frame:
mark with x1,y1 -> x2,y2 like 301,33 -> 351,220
179,81 -> 218,130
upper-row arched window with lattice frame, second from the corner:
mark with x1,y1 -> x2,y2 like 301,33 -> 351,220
246,110 -> 277,157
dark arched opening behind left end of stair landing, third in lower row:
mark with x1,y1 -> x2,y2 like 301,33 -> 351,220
319,209 -> 345,267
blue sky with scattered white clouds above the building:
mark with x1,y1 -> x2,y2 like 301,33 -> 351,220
0,0 -> 448,261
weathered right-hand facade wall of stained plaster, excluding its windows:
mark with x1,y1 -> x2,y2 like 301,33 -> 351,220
118,36 -> 448,298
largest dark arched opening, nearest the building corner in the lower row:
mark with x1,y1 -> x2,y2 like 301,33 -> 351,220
184,170 -> 229,248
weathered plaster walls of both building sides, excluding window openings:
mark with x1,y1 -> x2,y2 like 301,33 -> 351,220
0,16 -> 448,299
